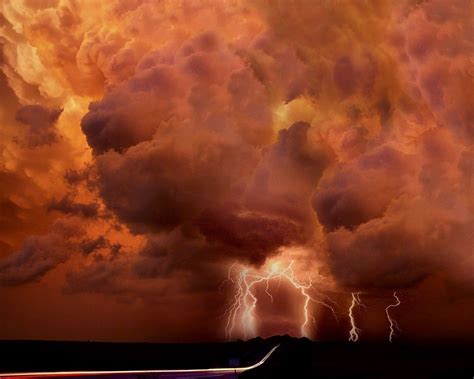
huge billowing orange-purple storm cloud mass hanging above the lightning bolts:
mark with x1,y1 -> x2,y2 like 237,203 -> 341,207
0,0 -> 474,338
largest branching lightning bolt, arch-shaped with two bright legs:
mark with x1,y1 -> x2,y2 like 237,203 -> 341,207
224,261 -> 337,340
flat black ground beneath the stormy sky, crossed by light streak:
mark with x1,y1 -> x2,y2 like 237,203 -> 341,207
0,336 -> 474,379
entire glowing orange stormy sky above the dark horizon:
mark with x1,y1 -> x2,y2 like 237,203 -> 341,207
0,0 -> 474,341
